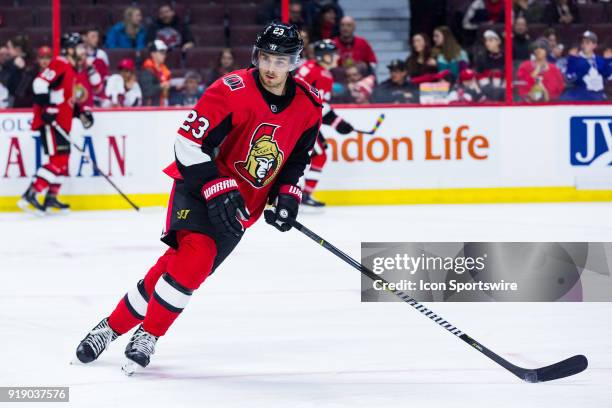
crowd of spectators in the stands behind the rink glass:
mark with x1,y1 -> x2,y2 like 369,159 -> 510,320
0,0 -> 612,108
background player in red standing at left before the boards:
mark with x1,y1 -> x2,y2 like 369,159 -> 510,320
17,33 -> 93,214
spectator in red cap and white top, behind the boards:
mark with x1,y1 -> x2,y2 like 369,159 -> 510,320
103,58 -> 142,108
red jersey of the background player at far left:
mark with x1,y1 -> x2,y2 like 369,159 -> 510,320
32,57 -> 76,132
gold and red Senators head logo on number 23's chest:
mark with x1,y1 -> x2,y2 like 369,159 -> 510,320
234,123 -> 284,188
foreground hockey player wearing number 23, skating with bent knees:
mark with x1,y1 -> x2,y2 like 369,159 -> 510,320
76,23 -> 322,374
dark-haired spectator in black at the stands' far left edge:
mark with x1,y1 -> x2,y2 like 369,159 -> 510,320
0,35 -> 37,108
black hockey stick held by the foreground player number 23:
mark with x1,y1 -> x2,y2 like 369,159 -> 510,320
284,217 -> 588,383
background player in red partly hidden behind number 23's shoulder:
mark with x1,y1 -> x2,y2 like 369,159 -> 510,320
296,40 -> 353,207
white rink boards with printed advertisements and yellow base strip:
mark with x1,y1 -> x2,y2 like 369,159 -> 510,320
0,105 -> 612,211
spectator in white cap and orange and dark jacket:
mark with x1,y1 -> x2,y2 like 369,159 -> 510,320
139,40 -> 171,106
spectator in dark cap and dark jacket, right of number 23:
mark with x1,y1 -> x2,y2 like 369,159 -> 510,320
372,59 -> 418,103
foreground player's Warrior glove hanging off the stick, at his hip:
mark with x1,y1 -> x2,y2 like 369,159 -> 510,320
202,177 -> 251,237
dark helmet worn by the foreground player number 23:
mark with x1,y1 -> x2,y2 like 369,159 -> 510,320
251,23 -> 304,70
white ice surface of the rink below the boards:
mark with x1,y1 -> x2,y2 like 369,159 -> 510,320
0,204 -> 612,408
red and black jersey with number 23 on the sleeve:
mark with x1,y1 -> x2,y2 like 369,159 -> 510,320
164,69 -> 321,227
